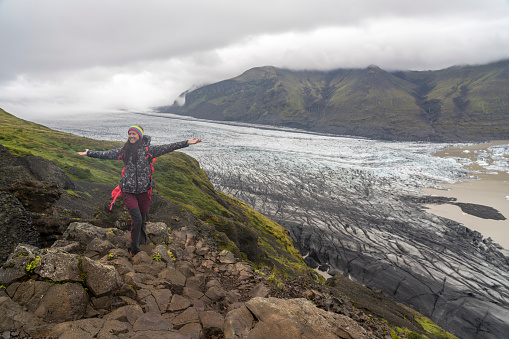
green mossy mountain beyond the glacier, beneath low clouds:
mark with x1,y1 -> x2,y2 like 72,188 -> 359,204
164,60 -> 509,141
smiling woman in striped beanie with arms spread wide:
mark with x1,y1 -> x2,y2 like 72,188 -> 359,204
78,125 -> 201,256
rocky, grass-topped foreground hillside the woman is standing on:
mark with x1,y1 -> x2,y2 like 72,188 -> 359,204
0,110 -> 455,338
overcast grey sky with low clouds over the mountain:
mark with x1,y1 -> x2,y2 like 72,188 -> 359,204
0,0 -> 509,118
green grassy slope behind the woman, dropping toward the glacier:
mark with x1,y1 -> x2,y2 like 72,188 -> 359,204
0,109 -> 314,275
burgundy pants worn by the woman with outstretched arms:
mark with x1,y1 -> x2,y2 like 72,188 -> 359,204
122,192 -> 150,254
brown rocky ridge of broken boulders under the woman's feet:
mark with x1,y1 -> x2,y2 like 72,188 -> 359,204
0,222 -> 396,338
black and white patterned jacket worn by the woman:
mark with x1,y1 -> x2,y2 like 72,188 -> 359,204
87,135 -> 189,194
